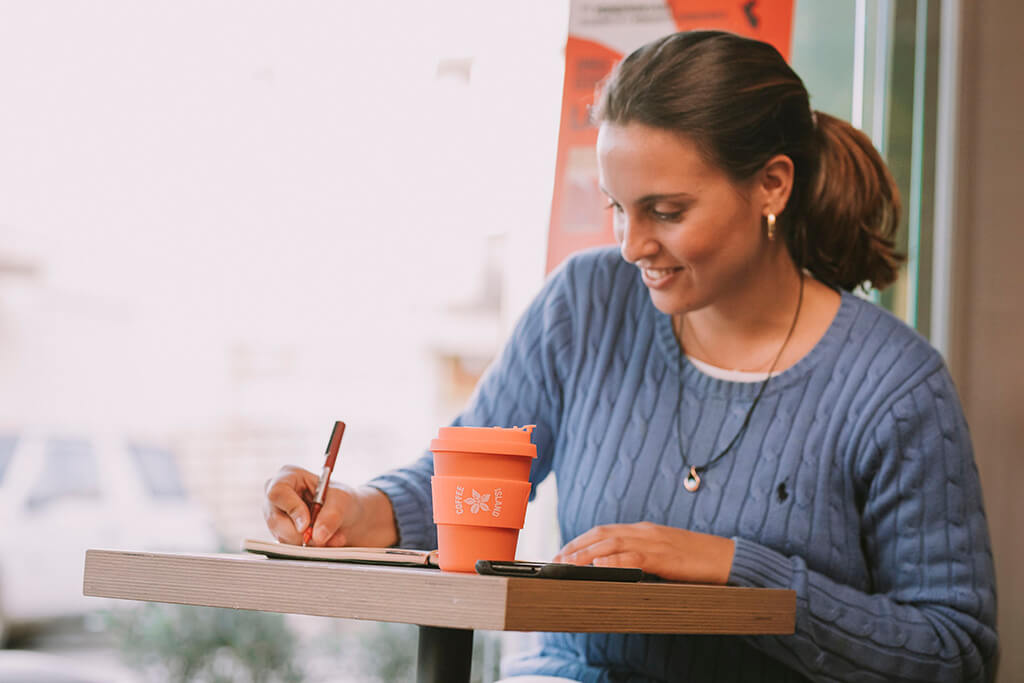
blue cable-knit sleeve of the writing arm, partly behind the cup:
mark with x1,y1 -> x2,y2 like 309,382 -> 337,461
368,260 -> 573,548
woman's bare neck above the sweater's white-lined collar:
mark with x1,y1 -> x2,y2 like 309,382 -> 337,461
674,259 -> 804,372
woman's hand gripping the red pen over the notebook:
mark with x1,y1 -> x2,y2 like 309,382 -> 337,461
263,465 -> 398,547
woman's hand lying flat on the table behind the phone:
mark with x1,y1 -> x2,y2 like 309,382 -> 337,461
553,522 -> 734,584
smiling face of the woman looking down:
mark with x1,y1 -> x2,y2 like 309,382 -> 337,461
597,123 -> 766,314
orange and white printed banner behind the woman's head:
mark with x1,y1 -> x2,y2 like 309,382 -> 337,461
547,0 -> 794,272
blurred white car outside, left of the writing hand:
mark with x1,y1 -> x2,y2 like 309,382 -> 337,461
0,431 -> 217,644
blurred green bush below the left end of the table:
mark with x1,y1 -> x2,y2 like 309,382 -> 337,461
109,603 -> 303,683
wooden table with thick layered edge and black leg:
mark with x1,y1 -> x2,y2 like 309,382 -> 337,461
83,550 -> 797,683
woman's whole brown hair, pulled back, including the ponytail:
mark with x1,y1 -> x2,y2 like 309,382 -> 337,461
593,31 -> 903,290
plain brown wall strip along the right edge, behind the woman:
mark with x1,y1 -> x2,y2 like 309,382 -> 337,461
952,0 -> 1024,683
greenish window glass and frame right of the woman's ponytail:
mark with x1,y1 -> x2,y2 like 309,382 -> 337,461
793,0 -> 949,335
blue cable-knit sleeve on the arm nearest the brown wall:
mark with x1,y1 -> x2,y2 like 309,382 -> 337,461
729,367 -> 997,683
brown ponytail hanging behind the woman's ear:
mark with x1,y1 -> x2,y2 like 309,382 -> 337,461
786,112 -> 904,290
